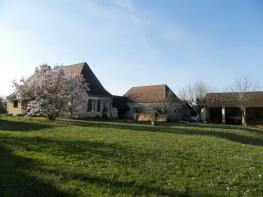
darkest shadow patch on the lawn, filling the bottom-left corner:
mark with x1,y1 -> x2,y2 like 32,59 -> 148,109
0,145 -> 69,197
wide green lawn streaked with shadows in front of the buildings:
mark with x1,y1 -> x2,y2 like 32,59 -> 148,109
0,116 -> 263,196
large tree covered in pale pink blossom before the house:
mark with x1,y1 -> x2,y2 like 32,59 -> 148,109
14,64 -> 88,120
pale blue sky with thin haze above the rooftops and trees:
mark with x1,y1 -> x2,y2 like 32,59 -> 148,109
0,0 -> 263,95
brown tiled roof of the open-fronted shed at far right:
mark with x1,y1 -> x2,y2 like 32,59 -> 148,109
205,92 -> 263,107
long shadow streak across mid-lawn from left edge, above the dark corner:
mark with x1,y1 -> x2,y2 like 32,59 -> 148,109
0,136 -> 132,158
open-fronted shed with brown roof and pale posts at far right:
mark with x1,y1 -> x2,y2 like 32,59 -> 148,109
201,92 -> 263,124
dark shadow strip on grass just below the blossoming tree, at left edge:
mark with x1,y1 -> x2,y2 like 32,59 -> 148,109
0,119 -> 53,132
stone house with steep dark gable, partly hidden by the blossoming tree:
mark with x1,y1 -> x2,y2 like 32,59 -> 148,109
7,62 -> 112,118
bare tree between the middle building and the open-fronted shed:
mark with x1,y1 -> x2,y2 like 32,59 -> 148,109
179,81 -> 210,118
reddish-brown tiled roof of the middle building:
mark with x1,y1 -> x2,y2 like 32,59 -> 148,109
124,85 -> 180,103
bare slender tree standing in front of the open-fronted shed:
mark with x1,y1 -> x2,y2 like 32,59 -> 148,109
230,77 -> 258,126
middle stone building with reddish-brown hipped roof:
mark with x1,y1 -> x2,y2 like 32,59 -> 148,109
118,85 -> 191,120
